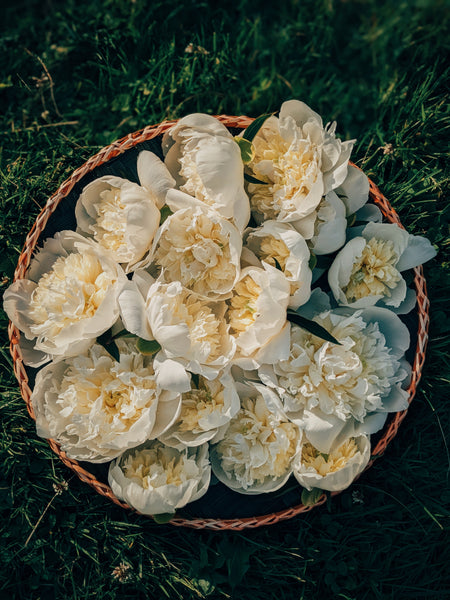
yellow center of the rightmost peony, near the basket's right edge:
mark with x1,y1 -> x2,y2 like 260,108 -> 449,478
343,238 -> 401,302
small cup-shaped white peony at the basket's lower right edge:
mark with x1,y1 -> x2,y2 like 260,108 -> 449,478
293,435 -> 370,492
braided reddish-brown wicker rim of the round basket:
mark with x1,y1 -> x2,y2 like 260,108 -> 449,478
8,115 -> 429,530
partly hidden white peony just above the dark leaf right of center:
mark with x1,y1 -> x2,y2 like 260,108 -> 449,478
245,221 -> 312,308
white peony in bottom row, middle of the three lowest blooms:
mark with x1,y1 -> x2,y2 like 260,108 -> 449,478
211,382 -> 300,494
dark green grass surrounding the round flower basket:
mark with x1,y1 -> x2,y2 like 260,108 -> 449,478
0,0 -> 450,600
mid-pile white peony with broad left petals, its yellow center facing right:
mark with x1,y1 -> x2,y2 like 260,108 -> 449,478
119,281 -> 236,392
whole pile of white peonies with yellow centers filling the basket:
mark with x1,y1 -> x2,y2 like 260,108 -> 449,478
4,100 -> 435,515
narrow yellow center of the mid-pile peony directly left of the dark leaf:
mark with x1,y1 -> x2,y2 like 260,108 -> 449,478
227,275 -> 262,336
